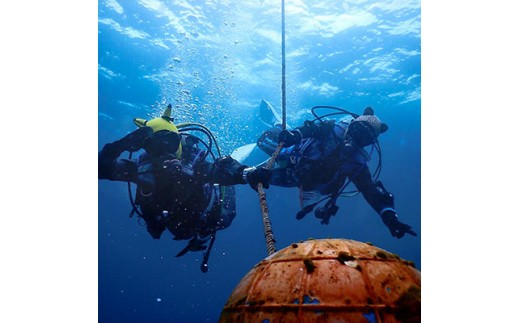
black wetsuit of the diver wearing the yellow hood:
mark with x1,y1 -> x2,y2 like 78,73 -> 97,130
98,131 -> 246,240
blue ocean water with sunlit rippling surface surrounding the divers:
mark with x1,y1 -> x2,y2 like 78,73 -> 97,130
98,0 -> 421,322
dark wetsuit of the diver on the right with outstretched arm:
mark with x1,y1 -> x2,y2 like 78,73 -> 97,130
257,121 -> 394,218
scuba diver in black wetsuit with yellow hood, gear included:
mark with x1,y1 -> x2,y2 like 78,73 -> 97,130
98,105 -> 268,272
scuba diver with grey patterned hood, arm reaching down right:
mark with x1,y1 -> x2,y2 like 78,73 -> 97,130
252,106 -> 417,239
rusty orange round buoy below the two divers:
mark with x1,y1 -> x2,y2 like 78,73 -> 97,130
219,239 -> 421,323
